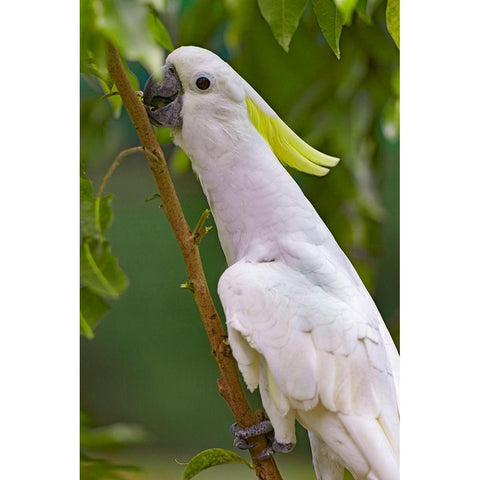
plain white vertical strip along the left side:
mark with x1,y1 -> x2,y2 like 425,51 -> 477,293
0,0 -> 79,480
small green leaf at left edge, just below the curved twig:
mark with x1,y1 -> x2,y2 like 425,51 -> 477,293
80,178 -> 113,239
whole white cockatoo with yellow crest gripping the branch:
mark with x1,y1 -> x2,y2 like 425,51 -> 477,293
144,47 -> 399,480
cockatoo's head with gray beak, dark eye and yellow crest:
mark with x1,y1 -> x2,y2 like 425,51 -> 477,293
143,47 -> 339,176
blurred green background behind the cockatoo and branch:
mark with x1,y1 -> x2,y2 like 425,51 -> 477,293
81,0 -> 399,479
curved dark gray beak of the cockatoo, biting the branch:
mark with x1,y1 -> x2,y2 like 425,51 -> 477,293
143,63 -> 183,127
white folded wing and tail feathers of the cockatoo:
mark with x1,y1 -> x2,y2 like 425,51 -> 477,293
219,262 -> 399,480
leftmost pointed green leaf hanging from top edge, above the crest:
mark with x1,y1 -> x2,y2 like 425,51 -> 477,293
258,0 -> 306,52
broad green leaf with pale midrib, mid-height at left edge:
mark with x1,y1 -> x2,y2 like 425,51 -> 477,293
80,238 -> 128,298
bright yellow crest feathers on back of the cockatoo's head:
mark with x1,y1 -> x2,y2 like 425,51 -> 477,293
246,96 -> 340,177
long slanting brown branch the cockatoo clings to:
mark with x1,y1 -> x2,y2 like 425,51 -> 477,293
107,44 -> 282,480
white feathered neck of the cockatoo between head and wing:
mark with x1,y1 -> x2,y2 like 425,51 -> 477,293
175,118 -> 318,265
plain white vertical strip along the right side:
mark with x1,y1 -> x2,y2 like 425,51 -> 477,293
401,0 -> 480,480
